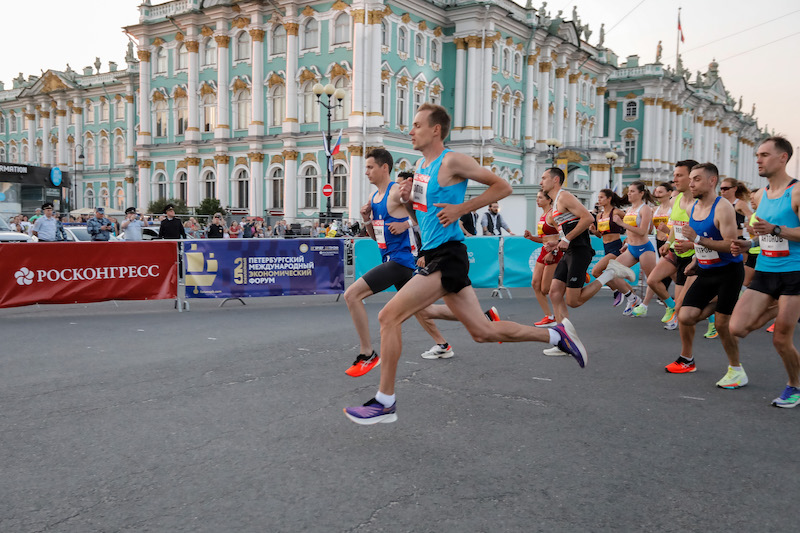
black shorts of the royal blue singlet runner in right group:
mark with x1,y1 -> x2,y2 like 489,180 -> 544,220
683,261 -> 744,315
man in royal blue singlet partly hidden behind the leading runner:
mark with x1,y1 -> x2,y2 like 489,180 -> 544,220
344,148 -> 453,377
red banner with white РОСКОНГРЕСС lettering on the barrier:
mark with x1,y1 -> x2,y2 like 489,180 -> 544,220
0,241 -> 178,307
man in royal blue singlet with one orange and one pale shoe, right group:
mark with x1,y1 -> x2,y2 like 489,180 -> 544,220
665,163 -> 747,389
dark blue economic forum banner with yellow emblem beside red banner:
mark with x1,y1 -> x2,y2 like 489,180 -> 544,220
183,239 -> 344,298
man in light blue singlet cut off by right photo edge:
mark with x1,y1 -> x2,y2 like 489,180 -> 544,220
731,136 -> 800,407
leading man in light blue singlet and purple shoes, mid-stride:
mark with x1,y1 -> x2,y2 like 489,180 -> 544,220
344,104 -> 587,424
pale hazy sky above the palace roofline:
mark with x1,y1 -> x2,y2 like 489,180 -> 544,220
0,0 -> 800,171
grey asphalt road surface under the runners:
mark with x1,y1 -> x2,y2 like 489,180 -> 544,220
0,290 -> 800,533
